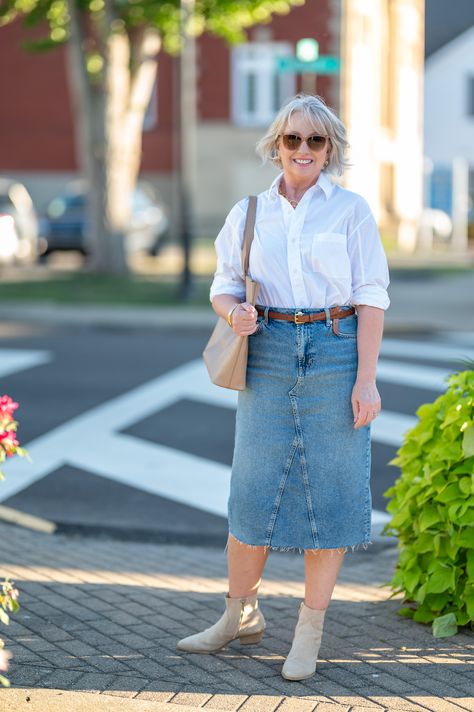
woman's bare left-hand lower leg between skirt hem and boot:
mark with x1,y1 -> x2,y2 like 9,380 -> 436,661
227,536 -> 269,598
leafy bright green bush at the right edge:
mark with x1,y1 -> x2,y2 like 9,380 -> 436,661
384,370 -> 474,637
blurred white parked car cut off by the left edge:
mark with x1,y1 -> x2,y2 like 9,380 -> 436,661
0,177 -> 38,264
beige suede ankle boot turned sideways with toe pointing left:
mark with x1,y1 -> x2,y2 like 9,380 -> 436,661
177,594 -> 265,653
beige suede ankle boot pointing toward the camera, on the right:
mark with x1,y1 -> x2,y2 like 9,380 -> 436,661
281,603 -> 326,680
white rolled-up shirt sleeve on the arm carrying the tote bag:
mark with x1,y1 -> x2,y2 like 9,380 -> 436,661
209,201 -> 245,301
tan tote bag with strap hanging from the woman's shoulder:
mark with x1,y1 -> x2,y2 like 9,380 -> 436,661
202,195 -> 260,391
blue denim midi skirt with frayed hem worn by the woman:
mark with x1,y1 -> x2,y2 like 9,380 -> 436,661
228,307 -> 371,552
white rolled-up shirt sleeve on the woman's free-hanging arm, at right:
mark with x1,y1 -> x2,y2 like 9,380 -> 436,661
347,201 -> 390,309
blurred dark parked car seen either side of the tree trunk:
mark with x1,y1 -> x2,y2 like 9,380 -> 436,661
40,181 -> 169,256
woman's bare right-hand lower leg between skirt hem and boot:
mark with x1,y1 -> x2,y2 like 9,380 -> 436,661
304,549 -> 344,611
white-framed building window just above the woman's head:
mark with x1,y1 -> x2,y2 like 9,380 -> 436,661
232,42 -> 295,126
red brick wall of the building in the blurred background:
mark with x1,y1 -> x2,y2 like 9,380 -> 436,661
0,0 -> 334,173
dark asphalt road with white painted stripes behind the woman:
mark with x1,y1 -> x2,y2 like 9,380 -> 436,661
0,323 -> 474,546
